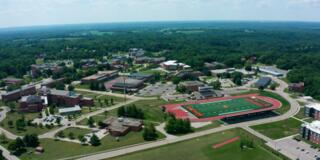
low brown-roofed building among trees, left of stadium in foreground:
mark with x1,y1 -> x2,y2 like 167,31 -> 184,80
103,117 -> 143,137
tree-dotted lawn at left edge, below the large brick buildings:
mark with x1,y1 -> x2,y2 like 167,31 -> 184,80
1,112 -> 55,136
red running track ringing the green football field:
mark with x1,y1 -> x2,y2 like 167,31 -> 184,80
163,94 -> 282,122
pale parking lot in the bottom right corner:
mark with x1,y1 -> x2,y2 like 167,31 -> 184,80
267,137 -> 320,160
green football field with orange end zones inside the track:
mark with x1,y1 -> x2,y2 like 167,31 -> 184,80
182,98 -> 262,118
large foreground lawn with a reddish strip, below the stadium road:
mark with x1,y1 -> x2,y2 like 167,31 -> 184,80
108,129 -> 280,160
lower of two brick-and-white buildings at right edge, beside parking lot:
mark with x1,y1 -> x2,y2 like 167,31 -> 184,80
300,121 -> 320,144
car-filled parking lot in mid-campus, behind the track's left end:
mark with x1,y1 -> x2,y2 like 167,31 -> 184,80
137,83 -> 176,96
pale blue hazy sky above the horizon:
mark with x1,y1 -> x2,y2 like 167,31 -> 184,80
0,0 -> 320,28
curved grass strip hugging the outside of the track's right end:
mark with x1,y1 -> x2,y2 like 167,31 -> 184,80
232,90 -> 290,114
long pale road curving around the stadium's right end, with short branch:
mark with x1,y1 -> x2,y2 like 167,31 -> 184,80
67,78 -> 300,160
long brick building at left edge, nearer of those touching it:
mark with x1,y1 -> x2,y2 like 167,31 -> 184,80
1,85 -> 37,102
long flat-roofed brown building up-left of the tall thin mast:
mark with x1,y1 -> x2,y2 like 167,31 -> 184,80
81,70 -> 119,83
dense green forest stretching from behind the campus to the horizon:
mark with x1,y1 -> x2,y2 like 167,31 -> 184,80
0,22 -> 320,99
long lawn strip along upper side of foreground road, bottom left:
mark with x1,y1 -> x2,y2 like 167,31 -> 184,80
20,132 -> 152,160
